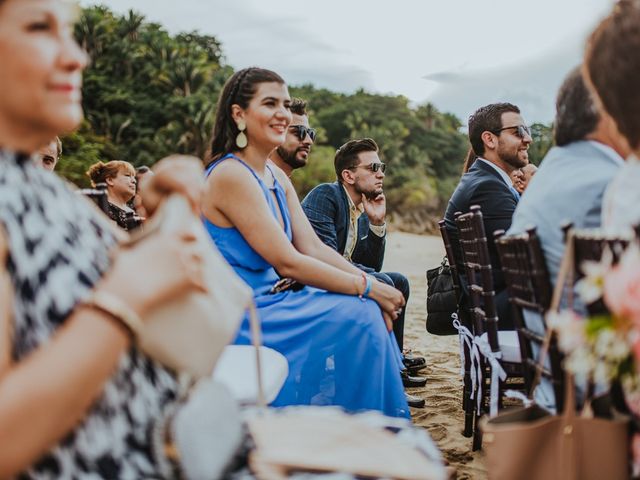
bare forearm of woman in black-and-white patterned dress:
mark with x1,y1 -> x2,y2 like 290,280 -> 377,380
0,309 -> 130,478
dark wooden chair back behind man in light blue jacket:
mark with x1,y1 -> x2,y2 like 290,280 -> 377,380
495,228 -> 564,411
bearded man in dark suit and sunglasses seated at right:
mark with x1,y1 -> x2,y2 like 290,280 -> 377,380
444,103 -> 531,330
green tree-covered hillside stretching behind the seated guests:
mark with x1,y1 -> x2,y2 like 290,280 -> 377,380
67,6 -> 552,231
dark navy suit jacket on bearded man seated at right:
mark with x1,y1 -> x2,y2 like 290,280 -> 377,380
444,160 -> 518,292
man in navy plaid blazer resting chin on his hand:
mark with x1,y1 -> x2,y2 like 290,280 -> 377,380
302,138 -> 426,407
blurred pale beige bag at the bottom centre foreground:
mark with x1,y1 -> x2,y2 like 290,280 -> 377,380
248,406 -> 447,480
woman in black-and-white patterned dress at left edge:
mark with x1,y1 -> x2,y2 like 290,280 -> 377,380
0,0 -> 202,479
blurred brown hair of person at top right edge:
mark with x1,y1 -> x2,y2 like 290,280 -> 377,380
585,0 -> 640,150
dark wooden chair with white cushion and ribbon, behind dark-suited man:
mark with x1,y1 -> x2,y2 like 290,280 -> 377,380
456,205 -> 523,450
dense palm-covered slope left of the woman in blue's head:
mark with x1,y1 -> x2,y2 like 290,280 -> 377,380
75,7 -> 231,171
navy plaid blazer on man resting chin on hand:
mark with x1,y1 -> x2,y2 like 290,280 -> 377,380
302,182 -> 385,273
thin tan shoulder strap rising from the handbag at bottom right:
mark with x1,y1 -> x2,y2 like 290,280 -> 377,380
529,229 -> 575,400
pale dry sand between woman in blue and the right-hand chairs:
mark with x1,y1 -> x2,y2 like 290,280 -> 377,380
383,232 -> 487,479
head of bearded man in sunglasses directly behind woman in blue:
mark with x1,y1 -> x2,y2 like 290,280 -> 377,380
270,98 -> 316,177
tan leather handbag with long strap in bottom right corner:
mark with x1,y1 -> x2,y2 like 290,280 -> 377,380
480,235 -> 629,480
